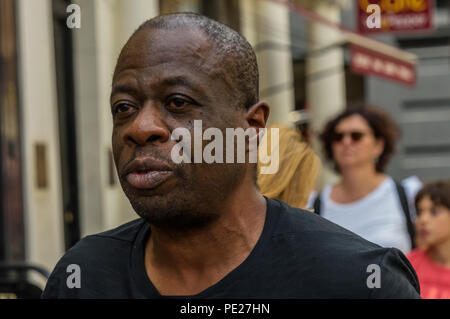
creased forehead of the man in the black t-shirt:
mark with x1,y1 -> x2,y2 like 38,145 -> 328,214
113,29 -> 233,99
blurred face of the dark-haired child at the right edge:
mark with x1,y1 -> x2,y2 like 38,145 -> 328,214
416,196 -> 450,247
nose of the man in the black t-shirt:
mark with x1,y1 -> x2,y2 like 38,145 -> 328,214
124,103 -> 170,145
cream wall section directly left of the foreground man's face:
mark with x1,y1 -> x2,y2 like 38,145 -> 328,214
74,0 -> 159,236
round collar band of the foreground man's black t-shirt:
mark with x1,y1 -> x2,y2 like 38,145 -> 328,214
130,196 -> 276,299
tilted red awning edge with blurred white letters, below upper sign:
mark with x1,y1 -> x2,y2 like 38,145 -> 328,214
351,46 -> 416,86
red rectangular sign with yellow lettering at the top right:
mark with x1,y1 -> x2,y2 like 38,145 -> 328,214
355,0 -> 433,33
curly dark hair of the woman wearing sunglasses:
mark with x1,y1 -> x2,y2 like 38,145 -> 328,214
320,105 -> 400,173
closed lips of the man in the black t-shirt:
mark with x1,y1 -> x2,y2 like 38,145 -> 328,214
125,156 -> 173,189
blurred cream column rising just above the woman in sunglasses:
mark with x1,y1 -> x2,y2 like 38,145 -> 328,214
306,0 -> 346,189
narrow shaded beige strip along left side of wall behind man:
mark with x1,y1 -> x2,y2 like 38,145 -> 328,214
73,0 -> 106,237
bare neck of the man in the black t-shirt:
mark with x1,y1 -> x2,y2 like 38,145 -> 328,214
145,174 -> 266,295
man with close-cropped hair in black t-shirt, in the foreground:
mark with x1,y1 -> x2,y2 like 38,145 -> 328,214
43,14 -> 419,299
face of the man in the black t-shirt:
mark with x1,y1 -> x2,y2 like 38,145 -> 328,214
111,26 -> 245,228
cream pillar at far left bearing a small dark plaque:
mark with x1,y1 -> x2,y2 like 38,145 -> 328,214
18,0 -> 64,284
